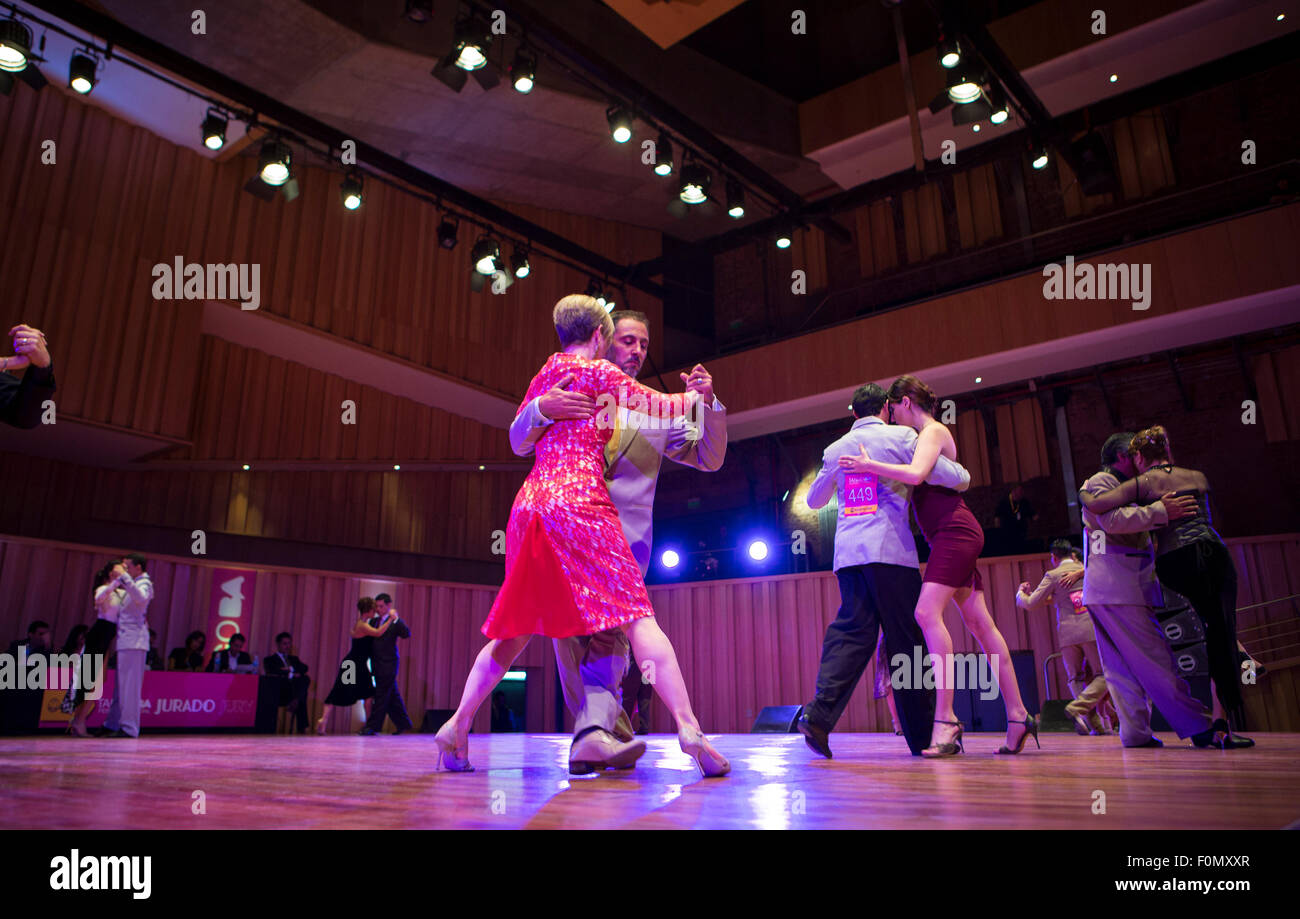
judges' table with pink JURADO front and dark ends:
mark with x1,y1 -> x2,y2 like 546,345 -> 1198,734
0,671 -> 285,733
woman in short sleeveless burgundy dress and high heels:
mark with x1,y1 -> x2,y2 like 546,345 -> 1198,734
840,377 -> 1039,757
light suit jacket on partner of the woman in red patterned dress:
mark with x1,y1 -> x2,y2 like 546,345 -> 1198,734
510,396 -> 727,576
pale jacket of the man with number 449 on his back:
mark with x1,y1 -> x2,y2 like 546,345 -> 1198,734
807,415 -> 971,571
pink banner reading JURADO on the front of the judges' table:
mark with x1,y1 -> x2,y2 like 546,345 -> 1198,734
40,671 -> 257,729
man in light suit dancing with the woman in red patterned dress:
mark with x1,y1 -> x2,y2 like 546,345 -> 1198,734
510,309 -> 727,775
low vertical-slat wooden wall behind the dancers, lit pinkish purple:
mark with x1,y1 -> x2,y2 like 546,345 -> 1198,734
0,534 -> 1300,744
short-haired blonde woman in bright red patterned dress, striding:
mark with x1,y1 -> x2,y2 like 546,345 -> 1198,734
436,294 -> 731,776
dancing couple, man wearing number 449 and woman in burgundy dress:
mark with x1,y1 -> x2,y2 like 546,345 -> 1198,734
798,376 -> 1039,758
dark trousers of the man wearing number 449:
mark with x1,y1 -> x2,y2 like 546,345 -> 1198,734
803,564 -> 935,757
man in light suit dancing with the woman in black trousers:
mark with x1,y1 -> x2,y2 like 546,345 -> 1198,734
1080,433 -> 1253,750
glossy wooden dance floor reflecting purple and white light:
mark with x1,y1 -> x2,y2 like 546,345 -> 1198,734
0,734 -> 1300,829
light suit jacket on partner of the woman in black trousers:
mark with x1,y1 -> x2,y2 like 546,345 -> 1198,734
1079,469 -> 1169,607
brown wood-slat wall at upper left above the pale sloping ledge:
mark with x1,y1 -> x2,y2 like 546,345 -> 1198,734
0,72 -> 662,438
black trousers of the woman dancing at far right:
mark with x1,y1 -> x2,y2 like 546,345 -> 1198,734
1156,539 -> 1242,719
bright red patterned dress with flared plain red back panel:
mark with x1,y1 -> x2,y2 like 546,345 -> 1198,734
482,354 -> 692,638
